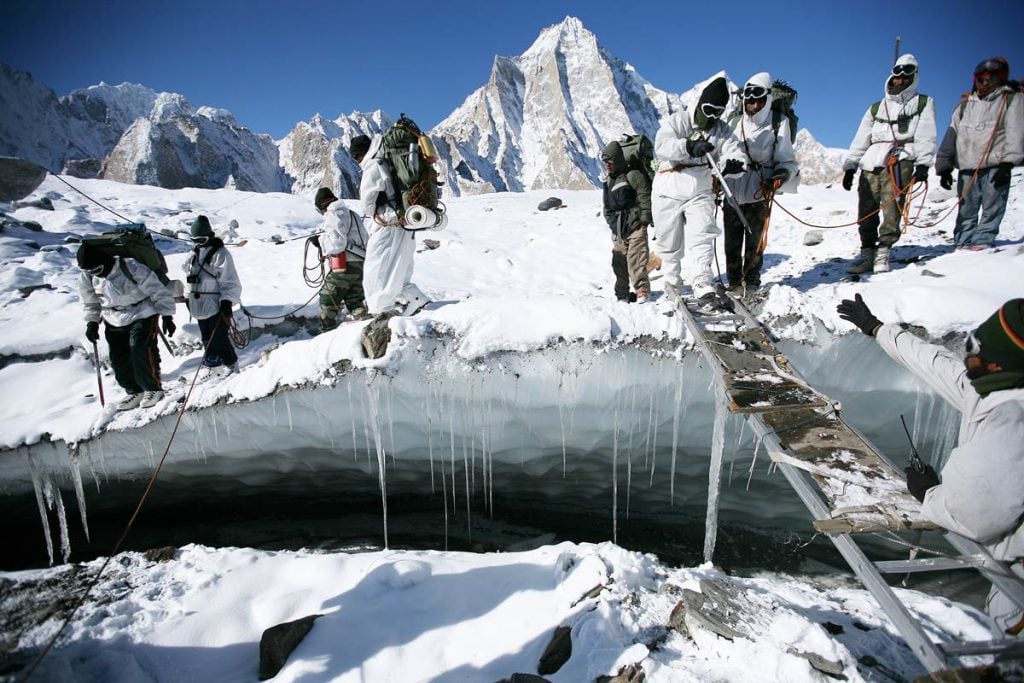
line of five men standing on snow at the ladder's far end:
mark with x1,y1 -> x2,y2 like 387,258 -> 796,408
602,54 -> 1024,310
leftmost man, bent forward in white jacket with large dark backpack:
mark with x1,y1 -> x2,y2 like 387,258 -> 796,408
77,244 -> 175,411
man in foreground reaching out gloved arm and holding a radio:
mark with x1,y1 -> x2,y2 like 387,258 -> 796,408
837,294 -> 1024,636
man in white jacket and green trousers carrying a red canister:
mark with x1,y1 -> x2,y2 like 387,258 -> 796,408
310,187 -> 370,332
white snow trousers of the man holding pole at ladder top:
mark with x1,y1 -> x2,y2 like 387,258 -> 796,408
651,169 -> 720,298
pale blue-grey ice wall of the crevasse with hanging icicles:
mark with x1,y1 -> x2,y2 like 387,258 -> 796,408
0,337 -> 956,561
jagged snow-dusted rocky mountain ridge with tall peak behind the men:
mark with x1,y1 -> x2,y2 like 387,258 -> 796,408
0,16 -> 840,197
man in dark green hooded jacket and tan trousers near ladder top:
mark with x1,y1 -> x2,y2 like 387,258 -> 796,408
601,141 -> 651,303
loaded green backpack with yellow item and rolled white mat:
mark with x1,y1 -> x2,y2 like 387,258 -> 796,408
383,114 -> 440,217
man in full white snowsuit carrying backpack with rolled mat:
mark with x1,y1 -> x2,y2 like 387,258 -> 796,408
349,135 -> 430,315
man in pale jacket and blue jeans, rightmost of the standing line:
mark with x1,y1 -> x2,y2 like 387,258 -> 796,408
935,57 -> 1024,251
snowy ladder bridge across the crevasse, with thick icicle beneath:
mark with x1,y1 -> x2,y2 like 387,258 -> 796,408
679,294 -> 1024,673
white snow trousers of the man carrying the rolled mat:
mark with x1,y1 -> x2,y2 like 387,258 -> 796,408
362,226 -> 427,315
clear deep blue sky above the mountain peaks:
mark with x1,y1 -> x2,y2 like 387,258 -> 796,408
0,0 -> 1024,147
